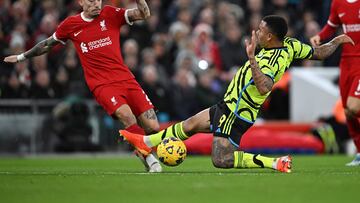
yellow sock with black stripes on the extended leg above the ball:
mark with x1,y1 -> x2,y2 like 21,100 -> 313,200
148,122 -> 189,147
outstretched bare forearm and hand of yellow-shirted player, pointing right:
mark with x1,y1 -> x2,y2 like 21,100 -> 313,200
311,34 -> 355,60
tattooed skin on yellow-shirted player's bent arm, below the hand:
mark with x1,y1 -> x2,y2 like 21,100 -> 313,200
249,58 -> 274,95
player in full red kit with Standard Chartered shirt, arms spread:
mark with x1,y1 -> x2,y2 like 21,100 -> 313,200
4,0 -> 161,172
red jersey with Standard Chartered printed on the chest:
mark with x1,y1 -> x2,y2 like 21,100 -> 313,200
53,6 -> 134,91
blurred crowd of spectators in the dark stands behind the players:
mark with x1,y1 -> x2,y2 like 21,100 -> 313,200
0,0 -> 339,121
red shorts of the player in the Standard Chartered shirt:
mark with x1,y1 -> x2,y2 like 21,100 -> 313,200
93,79 -> 154,117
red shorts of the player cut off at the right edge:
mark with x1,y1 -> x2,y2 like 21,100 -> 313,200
339,57 -> 360,106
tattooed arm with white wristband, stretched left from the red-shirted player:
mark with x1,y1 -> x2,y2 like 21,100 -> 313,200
4,36 -> 59,63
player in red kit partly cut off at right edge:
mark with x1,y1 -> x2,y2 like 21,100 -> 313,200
310,0 -> 360,166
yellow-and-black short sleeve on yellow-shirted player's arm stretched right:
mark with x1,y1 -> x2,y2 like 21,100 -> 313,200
285,38 -> 314,59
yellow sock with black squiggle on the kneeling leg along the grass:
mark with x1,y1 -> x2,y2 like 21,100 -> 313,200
234,151 -> 276,168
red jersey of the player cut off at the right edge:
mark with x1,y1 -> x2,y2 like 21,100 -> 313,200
319,0 -> 360,56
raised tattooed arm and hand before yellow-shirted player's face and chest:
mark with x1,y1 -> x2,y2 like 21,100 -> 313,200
245,31 -> 274,95
